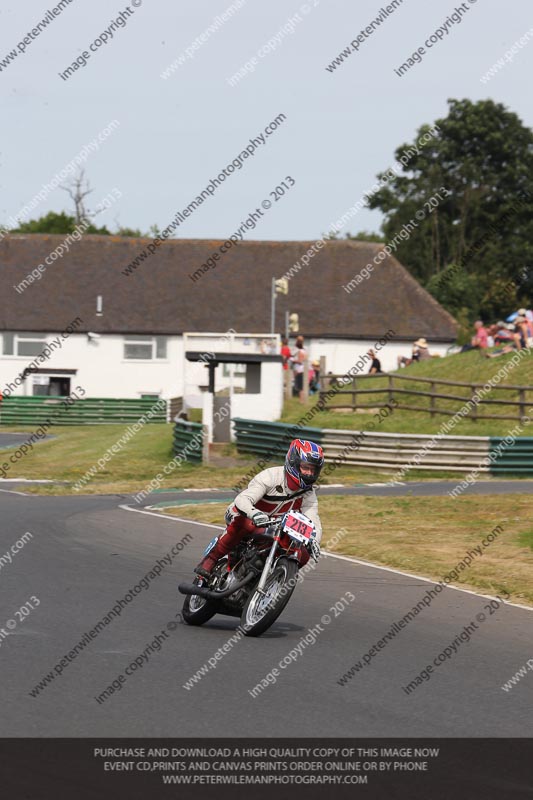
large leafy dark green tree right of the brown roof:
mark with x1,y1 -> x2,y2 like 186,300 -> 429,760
369,99 -> 533,320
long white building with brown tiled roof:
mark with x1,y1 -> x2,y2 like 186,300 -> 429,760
0,235 -> 456,412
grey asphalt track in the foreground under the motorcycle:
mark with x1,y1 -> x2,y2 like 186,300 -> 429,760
0,483 -> 533,737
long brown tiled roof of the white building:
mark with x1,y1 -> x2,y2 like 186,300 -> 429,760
0,234 -> 457,341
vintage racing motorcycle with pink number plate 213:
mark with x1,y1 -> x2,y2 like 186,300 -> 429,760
178,511 -> 320,636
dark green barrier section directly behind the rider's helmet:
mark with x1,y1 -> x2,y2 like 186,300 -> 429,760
232,417 -> 324,458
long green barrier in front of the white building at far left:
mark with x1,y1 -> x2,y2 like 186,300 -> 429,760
0,395 -> 167,425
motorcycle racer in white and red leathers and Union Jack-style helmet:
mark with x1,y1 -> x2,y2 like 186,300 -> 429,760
194,439 -> 324,578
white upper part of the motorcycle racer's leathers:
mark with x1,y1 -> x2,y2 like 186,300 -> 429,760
225,467 -> 322,542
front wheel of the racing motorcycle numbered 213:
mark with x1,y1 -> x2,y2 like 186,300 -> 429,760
241,558 -> 298,636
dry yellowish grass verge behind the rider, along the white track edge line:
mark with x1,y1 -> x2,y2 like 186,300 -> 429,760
160,495 -> 533,606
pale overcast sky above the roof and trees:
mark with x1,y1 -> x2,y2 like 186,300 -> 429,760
0,0 -> 533,244
